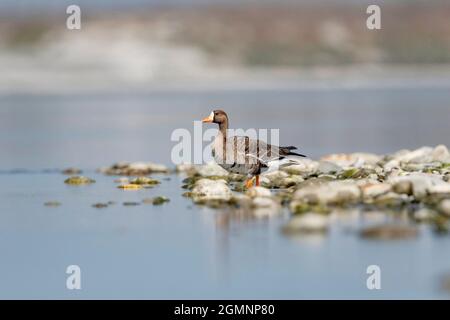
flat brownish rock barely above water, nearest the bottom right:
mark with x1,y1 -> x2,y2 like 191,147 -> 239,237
360,224 -> 419,240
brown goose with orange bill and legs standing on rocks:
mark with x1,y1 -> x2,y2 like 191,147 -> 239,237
202,110 -> 305,188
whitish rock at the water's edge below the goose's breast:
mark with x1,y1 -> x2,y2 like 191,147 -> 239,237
191,178 -> 232,202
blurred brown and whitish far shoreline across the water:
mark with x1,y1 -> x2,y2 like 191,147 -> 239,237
0,1 -> 450,94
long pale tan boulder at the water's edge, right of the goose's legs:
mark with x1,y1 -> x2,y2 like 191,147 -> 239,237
293,180 -> 361,204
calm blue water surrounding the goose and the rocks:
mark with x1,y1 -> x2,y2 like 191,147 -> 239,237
0,87 -> 450,299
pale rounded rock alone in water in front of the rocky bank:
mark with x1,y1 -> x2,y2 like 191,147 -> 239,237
282,213 -> 329,234
